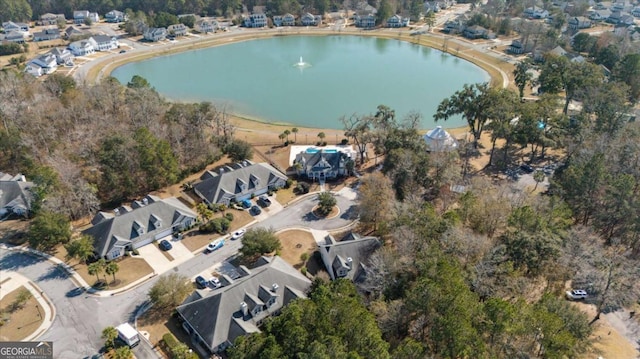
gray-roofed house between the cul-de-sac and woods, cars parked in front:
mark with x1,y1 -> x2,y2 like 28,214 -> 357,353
193,161 -> 287,205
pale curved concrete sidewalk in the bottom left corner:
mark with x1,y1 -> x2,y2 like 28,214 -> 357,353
0,271 -> 56,341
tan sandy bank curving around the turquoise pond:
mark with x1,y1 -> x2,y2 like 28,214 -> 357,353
81,28 -> 510,140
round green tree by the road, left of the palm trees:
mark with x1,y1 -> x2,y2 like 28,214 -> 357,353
27,211 -> 71,251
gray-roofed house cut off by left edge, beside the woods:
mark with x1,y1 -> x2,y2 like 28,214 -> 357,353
0,172 -> 34,218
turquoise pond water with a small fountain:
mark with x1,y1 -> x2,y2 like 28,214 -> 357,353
112,36 -> 489,129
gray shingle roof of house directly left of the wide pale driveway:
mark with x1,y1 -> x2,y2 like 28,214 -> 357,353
83,196 -> 196,257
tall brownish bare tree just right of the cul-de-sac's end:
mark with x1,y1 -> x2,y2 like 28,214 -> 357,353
360,172 -> 395,230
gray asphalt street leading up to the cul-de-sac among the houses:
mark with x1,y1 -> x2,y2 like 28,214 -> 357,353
0,190 -> 353,359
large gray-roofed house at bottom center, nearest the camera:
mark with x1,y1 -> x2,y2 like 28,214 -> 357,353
176,256 -> 311,357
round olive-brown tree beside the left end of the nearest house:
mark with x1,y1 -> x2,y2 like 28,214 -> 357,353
148,273 -> 193,312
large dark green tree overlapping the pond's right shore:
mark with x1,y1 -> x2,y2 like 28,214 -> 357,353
433,83 -> 496,148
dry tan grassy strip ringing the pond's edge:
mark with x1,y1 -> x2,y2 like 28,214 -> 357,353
85,28 -> 512,136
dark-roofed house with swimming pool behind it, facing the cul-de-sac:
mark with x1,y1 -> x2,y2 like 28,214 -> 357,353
293,149 -> 354,180
